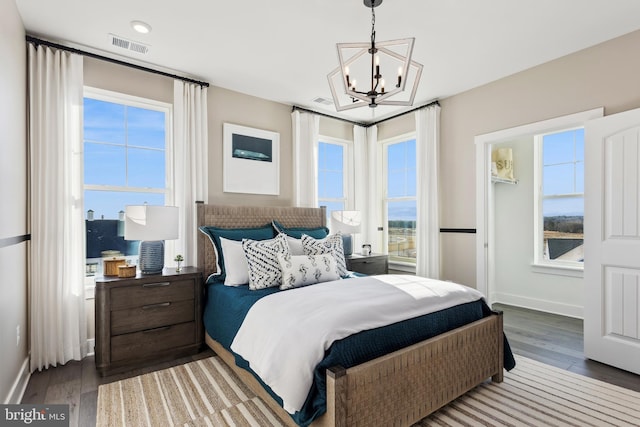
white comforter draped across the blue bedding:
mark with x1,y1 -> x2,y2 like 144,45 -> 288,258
231,275 -> 482,414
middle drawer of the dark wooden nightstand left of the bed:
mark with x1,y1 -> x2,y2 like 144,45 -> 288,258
111,299 -> 195,335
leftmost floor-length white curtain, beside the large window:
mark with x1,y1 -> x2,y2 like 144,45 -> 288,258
28,44 -> 87,372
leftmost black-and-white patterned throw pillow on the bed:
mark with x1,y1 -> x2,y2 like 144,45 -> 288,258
242,233 -> 289,290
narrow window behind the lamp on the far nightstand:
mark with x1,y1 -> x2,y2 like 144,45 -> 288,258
318,138 -> 347,224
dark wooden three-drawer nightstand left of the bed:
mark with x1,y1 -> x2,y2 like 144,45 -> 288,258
95,267 -> 204,376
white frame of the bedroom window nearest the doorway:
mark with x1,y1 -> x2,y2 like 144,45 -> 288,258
379,132 -> 419,271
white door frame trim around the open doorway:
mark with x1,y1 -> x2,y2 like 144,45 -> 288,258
474,107 -> 604,306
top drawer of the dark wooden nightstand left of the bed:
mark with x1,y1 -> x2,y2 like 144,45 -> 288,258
111,277 -> 195,311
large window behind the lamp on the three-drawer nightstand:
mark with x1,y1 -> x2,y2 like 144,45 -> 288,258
83,88 -> 172,275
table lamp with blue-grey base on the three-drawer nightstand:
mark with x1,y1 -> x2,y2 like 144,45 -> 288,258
124,205 -> 178,274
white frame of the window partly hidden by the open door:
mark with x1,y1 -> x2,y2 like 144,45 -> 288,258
533,126 -> 585,277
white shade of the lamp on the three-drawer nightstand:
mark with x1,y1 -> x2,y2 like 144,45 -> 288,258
124,205 -> 178,240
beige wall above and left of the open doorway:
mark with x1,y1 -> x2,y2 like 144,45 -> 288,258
440,32 -> 640,286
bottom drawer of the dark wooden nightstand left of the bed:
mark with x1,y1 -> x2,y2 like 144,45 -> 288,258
111,322 -> 196,362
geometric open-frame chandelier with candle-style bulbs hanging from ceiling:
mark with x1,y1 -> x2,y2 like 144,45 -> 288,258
327,0 -> 422,111
